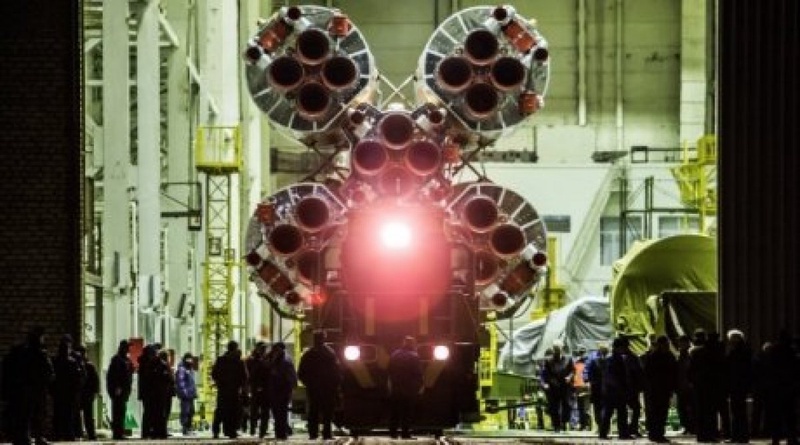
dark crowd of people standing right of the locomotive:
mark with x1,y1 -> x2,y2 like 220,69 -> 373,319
539,329 -> 800,444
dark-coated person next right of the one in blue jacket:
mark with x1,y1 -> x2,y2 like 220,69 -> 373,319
211,341 -> 247,439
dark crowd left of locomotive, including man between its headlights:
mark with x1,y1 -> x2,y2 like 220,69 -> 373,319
2,328 -> 422,444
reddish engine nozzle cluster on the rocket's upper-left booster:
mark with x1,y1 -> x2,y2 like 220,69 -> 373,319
245,6 -> 359,121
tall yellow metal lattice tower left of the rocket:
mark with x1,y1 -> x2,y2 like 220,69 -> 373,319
195,126 -> 241,421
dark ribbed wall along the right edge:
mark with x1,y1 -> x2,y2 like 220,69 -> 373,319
719,0 -> 800,344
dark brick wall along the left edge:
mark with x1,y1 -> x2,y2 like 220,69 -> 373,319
0,0 -> 81,354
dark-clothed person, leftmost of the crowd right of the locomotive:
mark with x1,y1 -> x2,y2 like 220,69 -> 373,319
541,340 -> 575,433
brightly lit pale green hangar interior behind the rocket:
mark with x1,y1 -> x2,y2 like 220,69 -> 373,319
82,0 -> 717,430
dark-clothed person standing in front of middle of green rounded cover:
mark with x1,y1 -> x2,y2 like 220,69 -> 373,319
642,335 -> 678,443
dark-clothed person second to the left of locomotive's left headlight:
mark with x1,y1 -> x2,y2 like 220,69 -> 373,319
268,342 -> 297,440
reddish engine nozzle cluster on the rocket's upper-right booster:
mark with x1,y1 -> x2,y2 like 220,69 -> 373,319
434,7 -> 549,120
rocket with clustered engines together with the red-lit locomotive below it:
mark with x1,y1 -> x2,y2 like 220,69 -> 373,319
243,5 -> 549,433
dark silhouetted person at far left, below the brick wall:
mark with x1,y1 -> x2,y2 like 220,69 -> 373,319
3,327 -> 55,445
